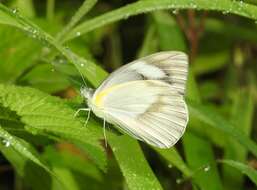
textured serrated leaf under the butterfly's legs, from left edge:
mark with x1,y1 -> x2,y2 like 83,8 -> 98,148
0,85 -> 106,169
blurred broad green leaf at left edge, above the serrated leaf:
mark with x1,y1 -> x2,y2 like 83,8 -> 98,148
0,26 -> 40,83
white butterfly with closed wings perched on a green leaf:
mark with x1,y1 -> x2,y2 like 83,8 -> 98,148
81,51 -> 188,148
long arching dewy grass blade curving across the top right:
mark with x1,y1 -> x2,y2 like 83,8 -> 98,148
64,0 -> 257,41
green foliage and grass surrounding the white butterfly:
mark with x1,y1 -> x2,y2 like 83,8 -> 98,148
0,0 -> 257,190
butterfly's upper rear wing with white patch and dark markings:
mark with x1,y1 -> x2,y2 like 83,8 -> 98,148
97,51 -> 188,94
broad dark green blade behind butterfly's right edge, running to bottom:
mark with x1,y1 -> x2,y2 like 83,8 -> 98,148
183,70 -> 222,190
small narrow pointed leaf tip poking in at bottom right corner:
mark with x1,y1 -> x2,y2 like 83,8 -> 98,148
220,160 -> 257,185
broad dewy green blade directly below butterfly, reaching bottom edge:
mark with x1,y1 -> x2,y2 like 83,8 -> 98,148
108,135 -> 162,190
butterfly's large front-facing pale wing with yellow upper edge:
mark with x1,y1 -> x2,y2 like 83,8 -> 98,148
92,80 -> 188,148
